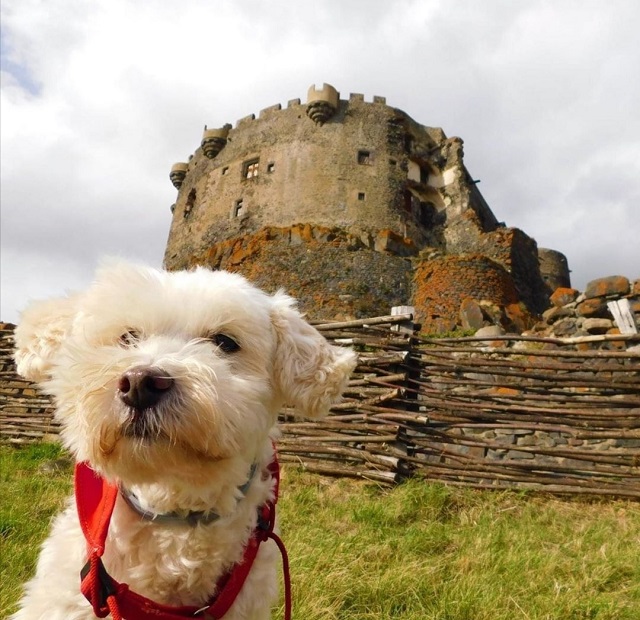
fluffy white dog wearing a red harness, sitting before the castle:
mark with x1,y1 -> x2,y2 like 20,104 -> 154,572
13,263 -> 355,620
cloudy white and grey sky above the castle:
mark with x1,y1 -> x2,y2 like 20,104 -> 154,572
0,0 -> 640,322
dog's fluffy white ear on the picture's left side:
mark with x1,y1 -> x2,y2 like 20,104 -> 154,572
14,297 -> 77,382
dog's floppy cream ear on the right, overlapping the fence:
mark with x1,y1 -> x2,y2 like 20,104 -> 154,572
272,293 -> 357,418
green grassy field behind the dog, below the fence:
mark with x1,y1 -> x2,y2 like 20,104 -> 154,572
0,446 -> 640,620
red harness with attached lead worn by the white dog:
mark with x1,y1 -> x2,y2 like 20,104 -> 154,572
75,453 -> 291,620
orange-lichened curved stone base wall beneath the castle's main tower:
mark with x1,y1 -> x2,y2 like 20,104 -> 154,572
191,224 -> 415,320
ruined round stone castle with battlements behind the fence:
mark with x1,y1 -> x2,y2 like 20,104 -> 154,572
164,84 -> 570,332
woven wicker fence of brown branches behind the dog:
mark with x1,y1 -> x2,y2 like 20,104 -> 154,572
0,315 -> 640,499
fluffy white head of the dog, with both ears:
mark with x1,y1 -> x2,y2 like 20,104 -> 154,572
15,263 -> 355,482
